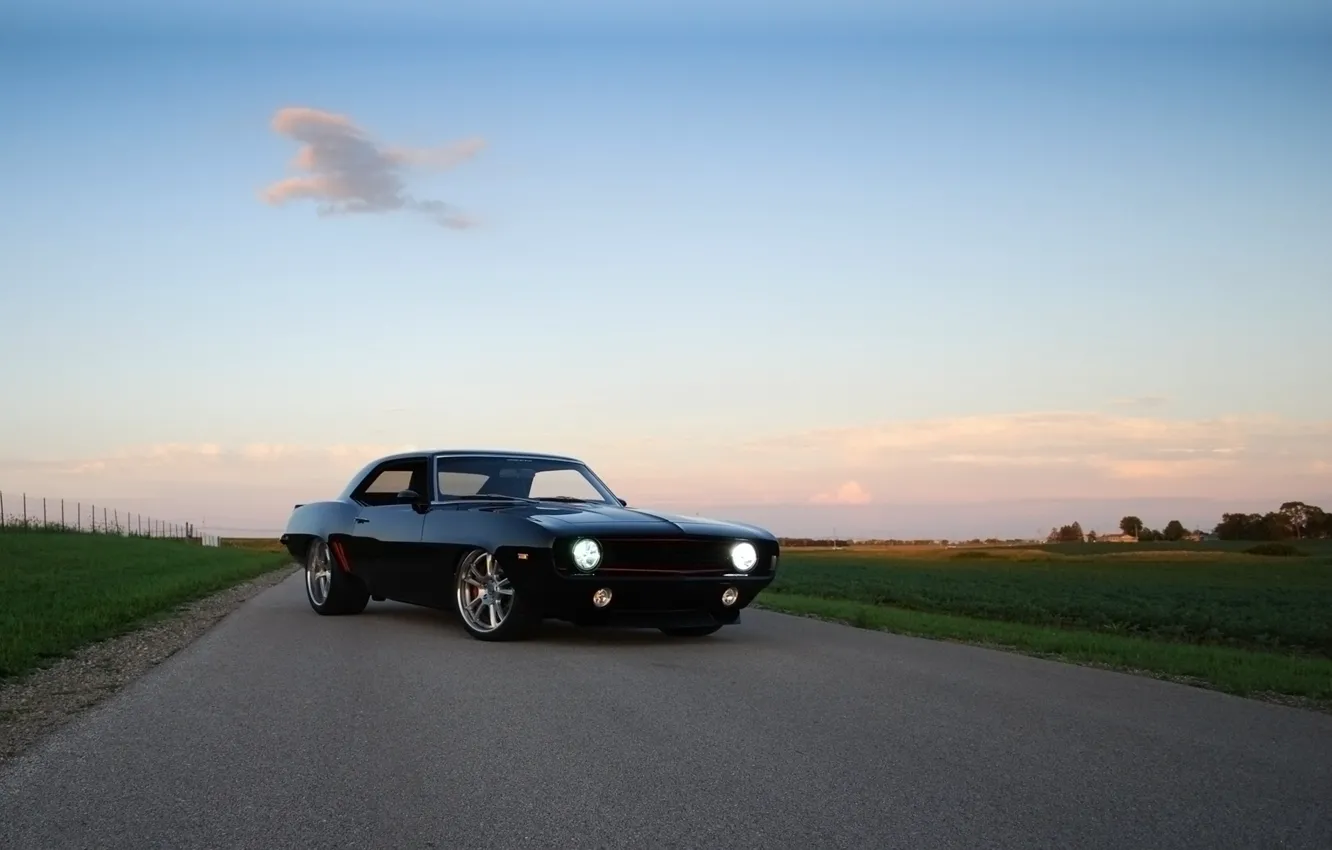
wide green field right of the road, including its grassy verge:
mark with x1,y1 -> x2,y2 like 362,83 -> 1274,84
759,541 -> 1332,702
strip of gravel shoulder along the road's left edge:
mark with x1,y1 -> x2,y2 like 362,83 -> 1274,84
0,562 -> 301,766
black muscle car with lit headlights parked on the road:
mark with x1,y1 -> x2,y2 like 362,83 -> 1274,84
281,450 -> 779,641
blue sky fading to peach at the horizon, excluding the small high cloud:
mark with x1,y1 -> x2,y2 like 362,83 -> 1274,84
0,0 -> 1332,533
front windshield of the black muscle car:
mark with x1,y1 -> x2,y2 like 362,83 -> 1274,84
436,454 -> 614,504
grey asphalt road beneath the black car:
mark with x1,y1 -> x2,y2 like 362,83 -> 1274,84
0,576 -> 1332,850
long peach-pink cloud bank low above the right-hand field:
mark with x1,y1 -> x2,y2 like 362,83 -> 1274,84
729,412 -> 1332,504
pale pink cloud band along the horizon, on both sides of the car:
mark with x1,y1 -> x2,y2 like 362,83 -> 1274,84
0,412 -> 1332,521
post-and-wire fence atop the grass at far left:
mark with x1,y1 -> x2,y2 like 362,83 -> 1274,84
0,490 -> 220,546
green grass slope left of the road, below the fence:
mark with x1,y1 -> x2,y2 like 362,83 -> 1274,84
0,530 -> 290,679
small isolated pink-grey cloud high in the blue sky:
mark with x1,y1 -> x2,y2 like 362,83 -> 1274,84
262,107 -> 485,228
